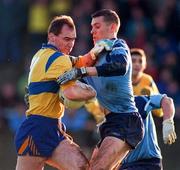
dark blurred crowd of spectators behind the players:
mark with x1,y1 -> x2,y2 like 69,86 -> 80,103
0,0 -> 180,170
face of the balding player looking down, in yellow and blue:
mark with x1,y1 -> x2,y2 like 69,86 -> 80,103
54,25 -> 76,54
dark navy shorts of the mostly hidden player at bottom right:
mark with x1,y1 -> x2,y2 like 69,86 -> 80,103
119,158 -> 163,170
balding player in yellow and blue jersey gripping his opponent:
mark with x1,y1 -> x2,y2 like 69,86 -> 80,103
15,15 -> 112,170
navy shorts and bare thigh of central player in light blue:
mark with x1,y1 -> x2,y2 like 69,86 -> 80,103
90,113 -> 143,170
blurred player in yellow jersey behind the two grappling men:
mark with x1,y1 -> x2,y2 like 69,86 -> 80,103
130,48 -> 163,117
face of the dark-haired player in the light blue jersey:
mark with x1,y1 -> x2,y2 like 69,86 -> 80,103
91,16 -> 111,44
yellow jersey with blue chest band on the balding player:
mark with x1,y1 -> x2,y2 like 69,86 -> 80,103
26,44 -> 73,118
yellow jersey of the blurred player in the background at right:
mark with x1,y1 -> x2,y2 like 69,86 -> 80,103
133,73 -> 163,117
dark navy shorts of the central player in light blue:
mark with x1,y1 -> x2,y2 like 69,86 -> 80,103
99,113 -> 144,149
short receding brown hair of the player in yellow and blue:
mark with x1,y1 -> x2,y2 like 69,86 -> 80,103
48,15 -> 75,35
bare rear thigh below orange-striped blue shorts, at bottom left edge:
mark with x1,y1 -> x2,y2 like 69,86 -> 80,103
16,156 -> 46,170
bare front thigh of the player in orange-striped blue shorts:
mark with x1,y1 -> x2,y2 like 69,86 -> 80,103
48,139 -> 89,170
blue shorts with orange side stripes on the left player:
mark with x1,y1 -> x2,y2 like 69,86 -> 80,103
15,115 -> 65,157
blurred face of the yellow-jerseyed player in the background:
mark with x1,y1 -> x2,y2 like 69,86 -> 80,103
131,54 -> 146,76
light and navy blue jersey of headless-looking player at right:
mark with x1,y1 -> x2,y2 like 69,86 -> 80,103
123,94 -> 164,164
